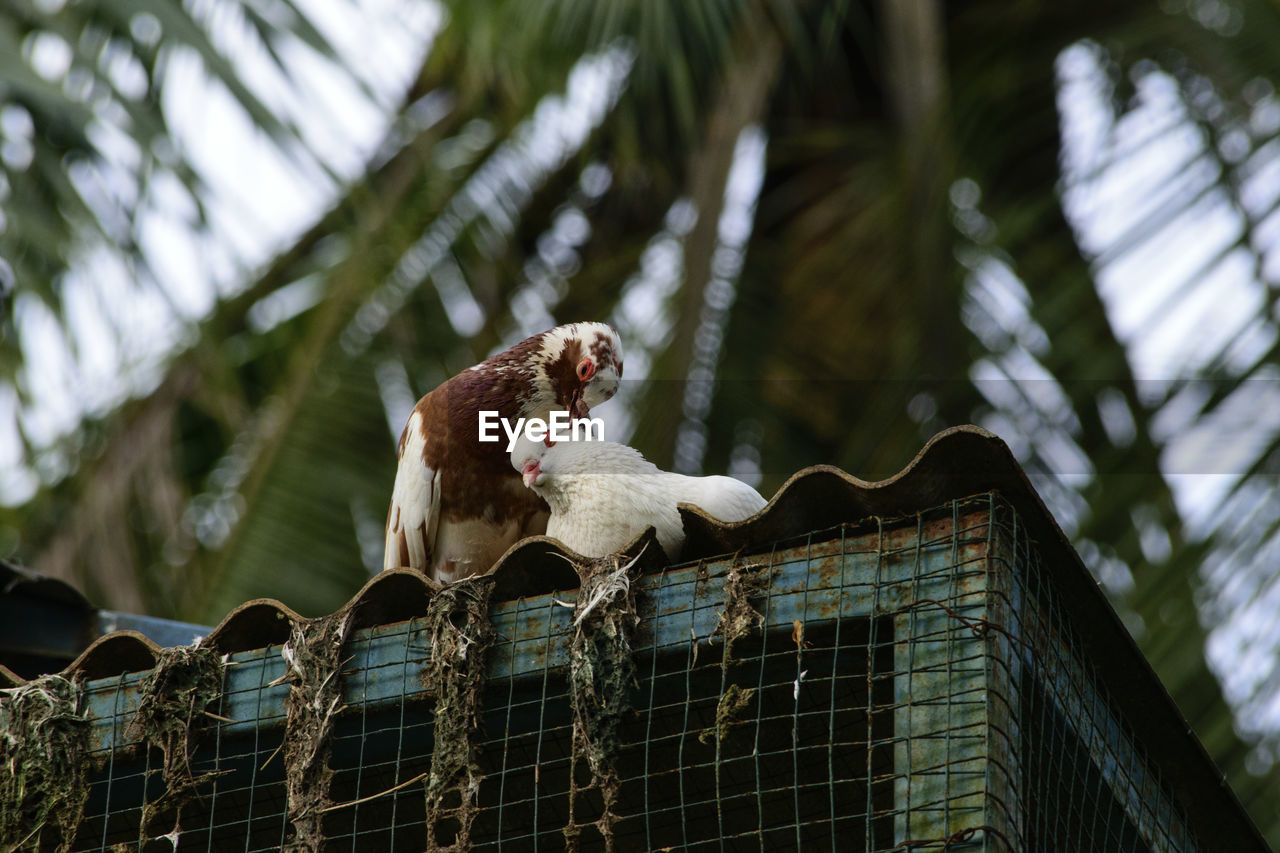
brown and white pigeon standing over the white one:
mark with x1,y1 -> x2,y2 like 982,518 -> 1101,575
383,323 -> 622,583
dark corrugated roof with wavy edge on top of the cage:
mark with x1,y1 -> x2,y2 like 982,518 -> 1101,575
0,427 -> 1261,849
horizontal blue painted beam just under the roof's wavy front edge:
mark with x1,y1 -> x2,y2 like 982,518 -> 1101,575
87,502 -> 986,752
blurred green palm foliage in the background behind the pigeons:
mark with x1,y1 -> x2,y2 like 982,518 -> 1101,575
0,0 -> 1280,844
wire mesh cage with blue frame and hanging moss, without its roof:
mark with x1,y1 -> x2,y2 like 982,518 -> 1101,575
9,493 -> 1239,852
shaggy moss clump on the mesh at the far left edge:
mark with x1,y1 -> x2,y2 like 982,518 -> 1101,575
0,675 -> 88,853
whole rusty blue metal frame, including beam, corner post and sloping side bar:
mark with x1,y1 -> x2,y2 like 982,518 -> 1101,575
74,496 -> 1213,850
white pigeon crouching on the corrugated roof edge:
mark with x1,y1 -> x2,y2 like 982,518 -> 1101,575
511,435 -> 767,560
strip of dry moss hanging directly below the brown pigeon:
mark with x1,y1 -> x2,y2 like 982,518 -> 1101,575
422,575 -> 495,853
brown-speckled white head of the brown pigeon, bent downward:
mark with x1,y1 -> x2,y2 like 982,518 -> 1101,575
534,323 -> 622,418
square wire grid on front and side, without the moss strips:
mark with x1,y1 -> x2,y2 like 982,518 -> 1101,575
55,496 -> 1197,852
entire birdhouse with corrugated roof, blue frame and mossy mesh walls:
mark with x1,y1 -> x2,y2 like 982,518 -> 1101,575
0,428 -> 1267,852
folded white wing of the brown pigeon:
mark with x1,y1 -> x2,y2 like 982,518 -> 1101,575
383,411 -> 442,573
